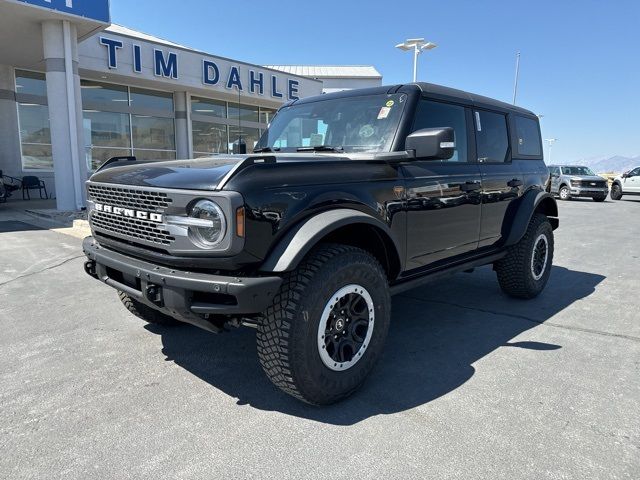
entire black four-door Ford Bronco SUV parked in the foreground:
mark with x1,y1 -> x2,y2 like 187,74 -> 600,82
84,83 -> 558,404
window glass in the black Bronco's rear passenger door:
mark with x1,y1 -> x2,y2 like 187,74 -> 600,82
475,111 -> 509,163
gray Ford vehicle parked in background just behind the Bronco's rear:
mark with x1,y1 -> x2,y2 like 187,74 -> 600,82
547,165 -> 609,202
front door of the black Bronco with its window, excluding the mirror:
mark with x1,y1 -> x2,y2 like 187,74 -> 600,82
401,99 -> 481,270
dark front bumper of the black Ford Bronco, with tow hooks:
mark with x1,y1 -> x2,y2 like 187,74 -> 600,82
82,237 -> 282,326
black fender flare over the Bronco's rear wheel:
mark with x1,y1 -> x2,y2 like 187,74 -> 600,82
503,190 -> 560,247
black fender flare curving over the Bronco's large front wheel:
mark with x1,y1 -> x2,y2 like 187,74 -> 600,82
260,208 -> 401,272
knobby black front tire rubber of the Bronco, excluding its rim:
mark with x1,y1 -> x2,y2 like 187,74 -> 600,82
257,244 -> 391,405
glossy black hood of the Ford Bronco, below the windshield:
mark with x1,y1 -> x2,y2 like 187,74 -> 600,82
90,155 -> 246,190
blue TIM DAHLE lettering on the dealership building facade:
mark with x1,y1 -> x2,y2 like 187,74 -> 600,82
100,37 -> 300,100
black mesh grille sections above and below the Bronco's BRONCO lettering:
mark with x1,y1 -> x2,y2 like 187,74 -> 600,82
88,184 -> 175,246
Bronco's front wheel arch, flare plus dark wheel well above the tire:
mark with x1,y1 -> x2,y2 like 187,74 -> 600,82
260,208 -> 402,279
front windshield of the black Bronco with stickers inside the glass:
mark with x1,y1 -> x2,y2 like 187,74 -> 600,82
255,94 -> 407,152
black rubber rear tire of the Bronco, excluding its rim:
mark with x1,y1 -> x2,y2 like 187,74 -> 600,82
494,213 -> 554,299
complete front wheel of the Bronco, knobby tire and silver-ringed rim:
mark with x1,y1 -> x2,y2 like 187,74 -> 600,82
257,244 -> 391,405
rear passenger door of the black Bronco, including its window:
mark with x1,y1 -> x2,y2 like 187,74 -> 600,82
473,109 -> 524,247
